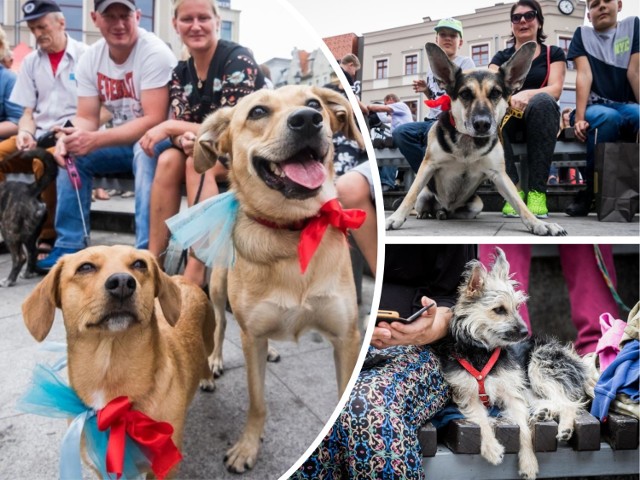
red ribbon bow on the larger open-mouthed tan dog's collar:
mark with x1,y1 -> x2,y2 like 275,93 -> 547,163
298,198 -> 367,273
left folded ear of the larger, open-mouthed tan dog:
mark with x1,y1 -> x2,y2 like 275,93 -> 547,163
193,108 -> 233,173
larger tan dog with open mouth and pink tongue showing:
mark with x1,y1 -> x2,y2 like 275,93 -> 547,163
195,86 -> 362,472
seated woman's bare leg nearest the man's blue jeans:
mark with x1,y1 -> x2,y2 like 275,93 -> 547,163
149,148 -> 185,265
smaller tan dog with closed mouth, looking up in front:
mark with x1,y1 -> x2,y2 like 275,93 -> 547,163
22,245 -> 214,473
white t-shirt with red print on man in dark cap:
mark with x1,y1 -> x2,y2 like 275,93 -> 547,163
77,28 -> 177,127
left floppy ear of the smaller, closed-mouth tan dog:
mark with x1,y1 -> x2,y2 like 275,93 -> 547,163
22,259 -> 64,342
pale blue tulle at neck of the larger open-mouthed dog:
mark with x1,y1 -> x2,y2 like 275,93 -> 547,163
166,192 -> 239,268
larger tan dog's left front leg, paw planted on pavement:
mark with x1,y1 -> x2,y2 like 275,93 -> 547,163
224,330 -> 268,473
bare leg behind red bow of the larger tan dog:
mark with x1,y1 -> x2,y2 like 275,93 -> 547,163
336,172 -> 378,276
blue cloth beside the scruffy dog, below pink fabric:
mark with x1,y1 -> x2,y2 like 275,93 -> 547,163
591,340 -> 640,420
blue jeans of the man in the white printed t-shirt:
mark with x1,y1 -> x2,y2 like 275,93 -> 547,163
55,142 -> 157,250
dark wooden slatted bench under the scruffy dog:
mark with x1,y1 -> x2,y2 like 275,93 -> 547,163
418,413 -> 640,480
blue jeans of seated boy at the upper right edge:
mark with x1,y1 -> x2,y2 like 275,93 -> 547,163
571,103 -> 640,189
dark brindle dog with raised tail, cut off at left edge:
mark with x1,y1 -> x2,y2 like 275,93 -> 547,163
0,148 -> 58,287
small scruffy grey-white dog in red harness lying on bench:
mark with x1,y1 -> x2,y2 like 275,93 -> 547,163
438,248 -> 587,479
